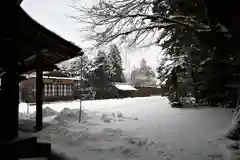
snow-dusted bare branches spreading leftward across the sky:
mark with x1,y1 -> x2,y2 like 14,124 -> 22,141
71,0 -> 210,47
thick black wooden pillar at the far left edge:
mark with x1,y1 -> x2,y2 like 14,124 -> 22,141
0,71 -> 19,142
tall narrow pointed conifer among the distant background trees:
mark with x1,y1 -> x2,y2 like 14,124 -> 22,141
108,44 -> 125,82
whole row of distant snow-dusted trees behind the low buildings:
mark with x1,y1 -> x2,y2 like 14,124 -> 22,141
60,44 -> 156,91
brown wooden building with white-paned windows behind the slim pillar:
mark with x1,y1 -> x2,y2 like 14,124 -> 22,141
20,71 -> 95,102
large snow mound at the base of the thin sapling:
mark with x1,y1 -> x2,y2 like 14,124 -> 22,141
54,108 -> 87,124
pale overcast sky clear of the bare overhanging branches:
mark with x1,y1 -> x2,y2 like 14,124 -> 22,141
21,0 -> 161,74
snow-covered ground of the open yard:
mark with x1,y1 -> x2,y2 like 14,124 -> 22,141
19,96 -> 232,160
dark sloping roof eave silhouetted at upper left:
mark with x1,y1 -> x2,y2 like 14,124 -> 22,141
0,5 -> 83,73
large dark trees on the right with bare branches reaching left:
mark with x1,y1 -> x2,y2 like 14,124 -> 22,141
70,0 -> 240,107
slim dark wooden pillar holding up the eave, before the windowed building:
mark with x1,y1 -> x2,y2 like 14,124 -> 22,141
36,53 -> 44,131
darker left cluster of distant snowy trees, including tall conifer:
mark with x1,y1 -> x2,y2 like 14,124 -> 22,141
61,44 -> 125,95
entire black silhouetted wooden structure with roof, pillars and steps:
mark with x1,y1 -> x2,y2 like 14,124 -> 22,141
0,0 -> 82,160
